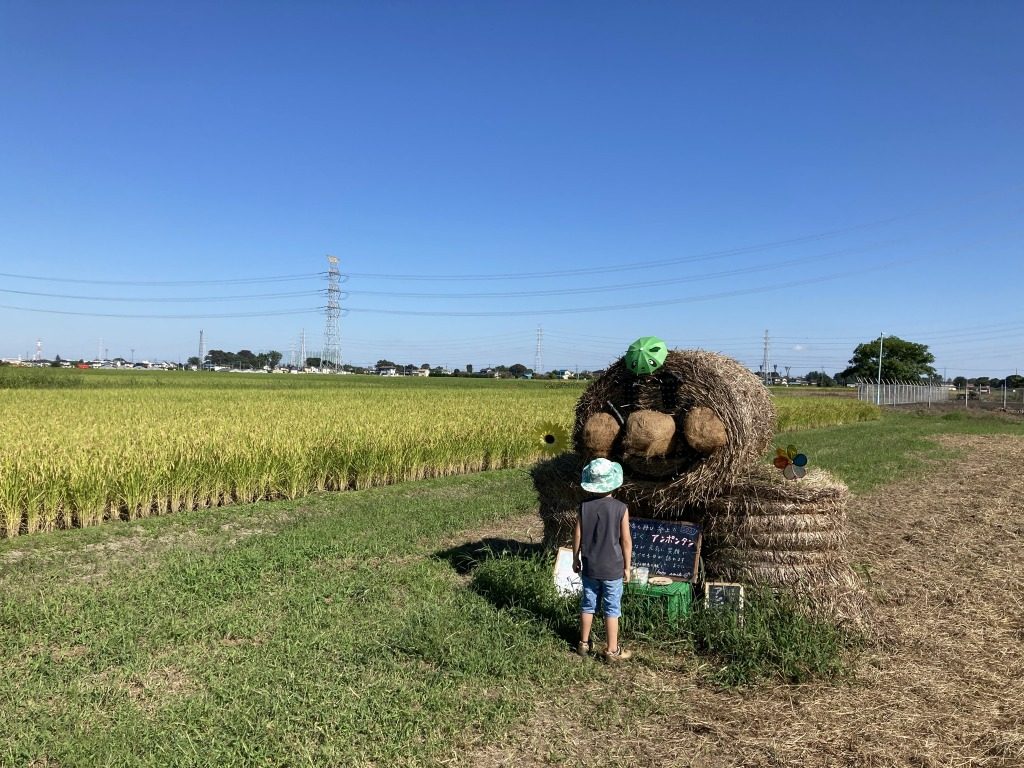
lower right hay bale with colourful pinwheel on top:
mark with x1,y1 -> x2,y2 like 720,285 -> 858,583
701,465 -> 865,624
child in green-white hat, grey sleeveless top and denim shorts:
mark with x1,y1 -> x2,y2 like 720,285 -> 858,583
572,459 -> 633,662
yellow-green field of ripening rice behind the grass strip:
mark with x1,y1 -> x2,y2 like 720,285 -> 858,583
0,369 -> 878,538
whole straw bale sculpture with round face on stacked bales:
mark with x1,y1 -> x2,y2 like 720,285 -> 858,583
531,337 -> 860,621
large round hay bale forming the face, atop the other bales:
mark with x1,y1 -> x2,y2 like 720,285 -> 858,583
572,349 -> 775,512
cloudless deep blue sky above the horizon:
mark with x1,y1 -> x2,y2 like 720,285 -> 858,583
0,0 -> 1024,377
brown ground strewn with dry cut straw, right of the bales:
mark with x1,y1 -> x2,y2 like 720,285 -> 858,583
465,436 -> 1024,768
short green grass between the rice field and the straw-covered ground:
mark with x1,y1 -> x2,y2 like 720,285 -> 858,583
0,414 -> 1024,766
